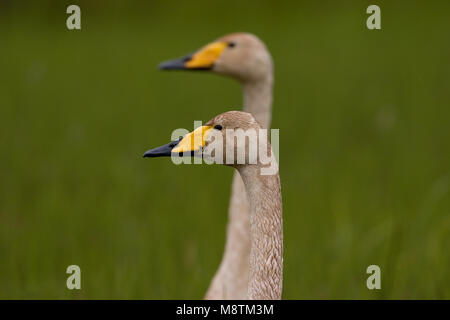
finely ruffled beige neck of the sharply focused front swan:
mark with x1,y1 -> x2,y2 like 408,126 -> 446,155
238,165 -> 283,299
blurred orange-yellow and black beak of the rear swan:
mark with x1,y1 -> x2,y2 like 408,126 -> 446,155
158,41 -> 228,70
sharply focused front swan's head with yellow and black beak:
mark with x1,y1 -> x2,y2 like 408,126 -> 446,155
144,111 -> 272,168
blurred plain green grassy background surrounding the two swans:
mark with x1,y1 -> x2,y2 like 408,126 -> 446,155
0,0 -> 450,299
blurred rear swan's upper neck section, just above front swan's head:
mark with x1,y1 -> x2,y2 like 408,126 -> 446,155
242,72 -> 273,129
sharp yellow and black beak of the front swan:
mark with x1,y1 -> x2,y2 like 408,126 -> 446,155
144,126 -> 213,158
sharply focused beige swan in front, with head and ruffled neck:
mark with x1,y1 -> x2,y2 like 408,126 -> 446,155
144,111 -> 283,300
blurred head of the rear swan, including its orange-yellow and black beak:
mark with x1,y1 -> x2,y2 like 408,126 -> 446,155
159,33 -> 273,82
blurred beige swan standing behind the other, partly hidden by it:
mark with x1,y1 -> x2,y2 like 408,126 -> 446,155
159,33 -> 273,299
